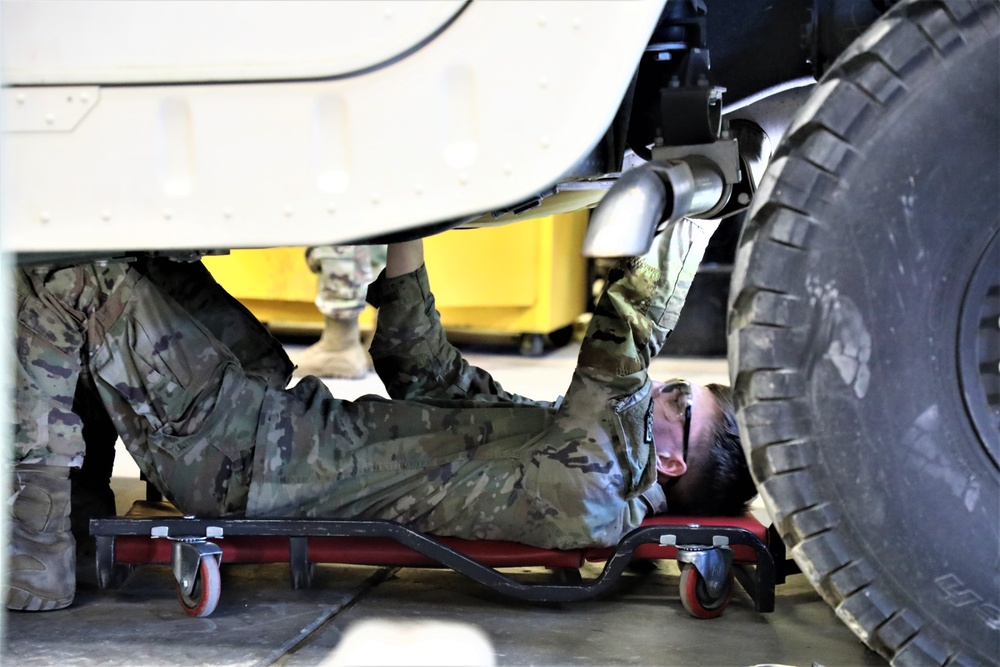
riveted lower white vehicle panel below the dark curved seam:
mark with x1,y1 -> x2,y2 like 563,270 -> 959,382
2,0 -> 664,252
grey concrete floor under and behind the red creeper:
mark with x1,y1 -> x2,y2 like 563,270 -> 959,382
0,344 -> 884,667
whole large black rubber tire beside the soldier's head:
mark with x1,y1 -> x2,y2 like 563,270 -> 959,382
729,0 -> 1000,666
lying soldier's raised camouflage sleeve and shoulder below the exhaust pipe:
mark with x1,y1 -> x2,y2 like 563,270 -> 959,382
525,220 -> 716,544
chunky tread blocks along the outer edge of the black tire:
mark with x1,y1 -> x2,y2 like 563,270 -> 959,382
729,0 -> 1000,665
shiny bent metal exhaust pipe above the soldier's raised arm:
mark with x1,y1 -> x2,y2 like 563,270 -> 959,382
583,156 -> 726,257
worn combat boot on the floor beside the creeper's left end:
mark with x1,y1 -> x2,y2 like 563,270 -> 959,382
7,465 -> 76,611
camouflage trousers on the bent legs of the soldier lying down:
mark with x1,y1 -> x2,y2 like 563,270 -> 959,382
13,260 -> 291,514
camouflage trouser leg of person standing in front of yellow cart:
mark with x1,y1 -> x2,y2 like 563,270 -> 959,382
306,245 -> 386,320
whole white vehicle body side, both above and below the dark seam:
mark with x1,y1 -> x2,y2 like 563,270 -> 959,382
0,0 -> 665,253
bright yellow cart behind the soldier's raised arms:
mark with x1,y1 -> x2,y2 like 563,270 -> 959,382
205,211 -> 589,355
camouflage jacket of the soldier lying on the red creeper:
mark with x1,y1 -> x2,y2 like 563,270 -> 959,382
247,220 -> 717,548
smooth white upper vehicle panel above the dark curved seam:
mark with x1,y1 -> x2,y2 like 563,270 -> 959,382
0,0 -> 468,85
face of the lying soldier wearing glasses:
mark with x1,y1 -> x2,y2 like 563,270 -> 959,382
653,380 -> 719,483
